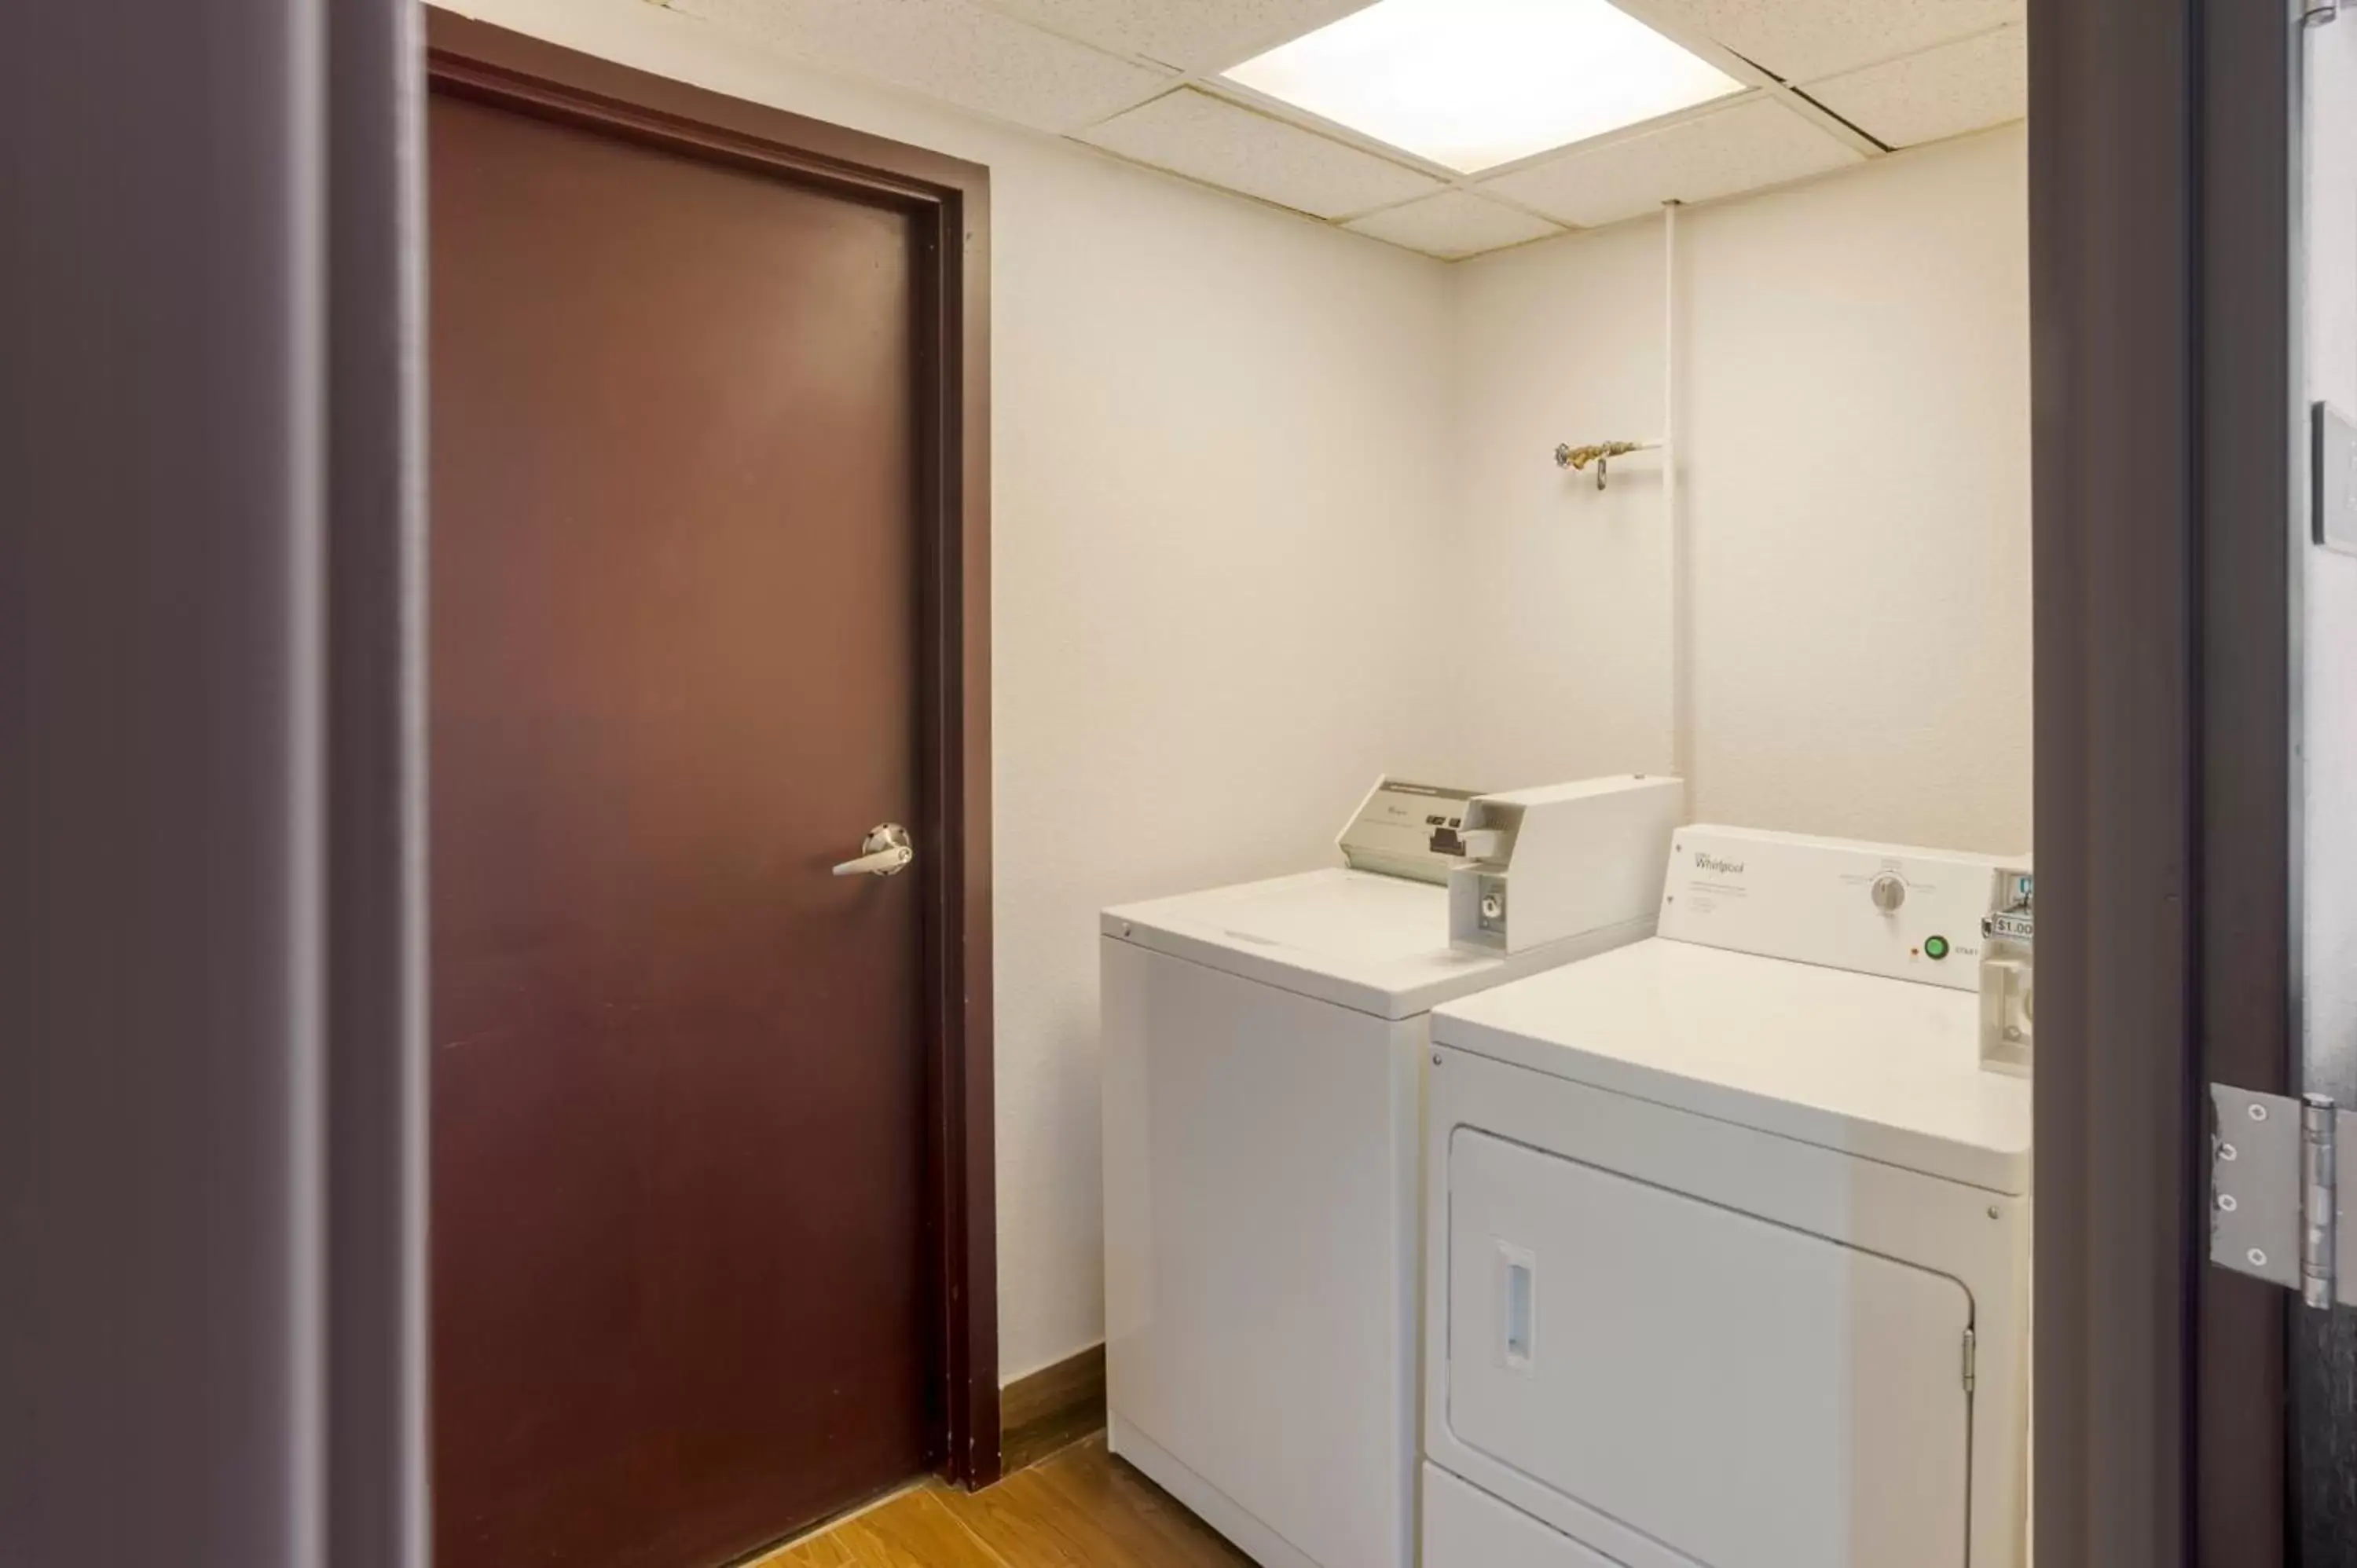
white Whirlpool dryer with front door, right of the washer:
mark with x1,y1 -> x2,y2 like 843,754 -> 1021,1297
1424,828 -> 2029,1568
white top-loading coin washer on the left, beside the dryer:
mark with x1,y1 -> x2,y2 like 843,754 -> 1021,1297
1101,778 -> 1683,1568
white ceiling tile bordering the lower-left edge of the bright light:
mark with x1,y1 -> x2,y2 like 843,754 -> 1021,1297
1082,87 -> 1442,217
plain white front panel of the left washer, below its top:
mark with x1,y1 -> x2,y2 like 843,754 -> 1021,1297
1101,939 -> 1426,1568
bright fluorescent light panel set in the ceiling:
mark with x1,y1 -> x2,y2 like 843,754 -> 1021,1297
1226,0 -> 1742,174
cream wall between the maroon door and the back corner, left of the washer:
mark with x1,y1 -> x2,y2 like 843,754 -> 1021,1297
422,0 -> 1450,1377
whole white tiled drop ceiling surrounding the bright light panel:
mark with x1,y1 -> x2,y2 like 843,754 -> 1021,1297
669,0 -> 2027,259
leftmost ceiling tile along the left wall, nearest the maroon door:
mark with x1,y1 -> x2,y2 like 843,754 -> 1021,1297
672,0 -> 1171,132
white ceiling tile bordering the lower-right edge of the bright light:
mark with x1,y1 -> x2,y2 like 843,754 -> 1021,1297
1478,97 -> 1864,229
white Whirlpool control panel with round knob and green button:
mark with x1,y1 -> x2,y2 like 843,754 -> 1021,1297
1662,826 -> 2022,991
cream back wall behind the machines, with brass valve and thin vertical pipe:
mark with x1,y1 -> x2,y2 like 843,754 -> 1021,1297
1452,125 -> 2029,852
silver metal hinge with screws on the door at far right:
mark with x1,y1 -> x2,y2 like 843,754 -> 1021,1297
2211,1085 -> 2357,1309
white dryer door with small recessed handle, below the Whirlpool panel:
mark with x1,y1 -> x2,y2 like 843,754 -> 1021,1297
1447,1127 -> 1973,1568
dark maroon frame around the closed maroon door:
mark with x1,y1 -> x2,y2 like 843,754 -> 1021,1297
427,9 -> 999,1488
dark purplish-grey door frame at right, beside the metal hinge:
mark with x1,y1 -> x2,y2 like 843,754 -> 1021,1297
2029,0 -> 2305,1568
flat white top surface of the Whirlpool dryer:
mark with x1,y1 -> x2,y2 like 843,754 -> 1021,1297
1433,936 -> 2029,1193
